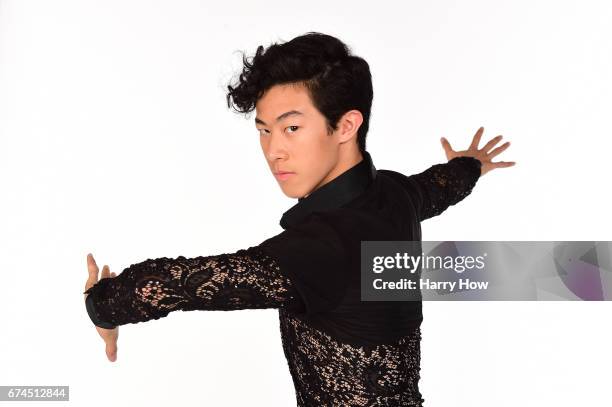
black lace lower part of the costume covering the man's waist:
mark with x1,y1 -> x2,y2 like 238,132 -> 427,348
279,309 -> 424,407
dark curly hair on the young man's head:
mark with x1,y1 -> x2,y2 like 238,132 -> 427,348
227,31 -> 373,151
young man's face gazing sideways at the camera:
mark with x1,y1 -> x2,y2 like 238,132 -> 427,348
255,85 -> 340,198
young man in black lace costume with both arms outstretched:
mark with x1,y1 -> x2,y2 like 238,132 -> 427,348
85,33 -> 514,406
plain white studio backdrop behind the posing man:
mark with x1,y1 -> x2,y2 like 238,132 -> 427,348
0,0 -> 612,407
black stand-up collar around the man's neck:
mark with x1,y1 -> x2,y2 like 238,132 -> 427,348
280,151 -> 376,229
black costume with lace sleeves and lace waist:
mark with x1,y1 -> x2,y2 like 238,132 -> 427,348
86,152 -> 481,406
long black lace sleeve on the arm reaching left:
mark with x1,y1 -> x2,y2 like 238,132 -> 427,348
85,246 -> 301,328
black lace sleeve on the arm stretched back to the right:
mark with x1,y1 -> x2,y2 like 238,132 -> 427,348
407,156 -> 482,221
